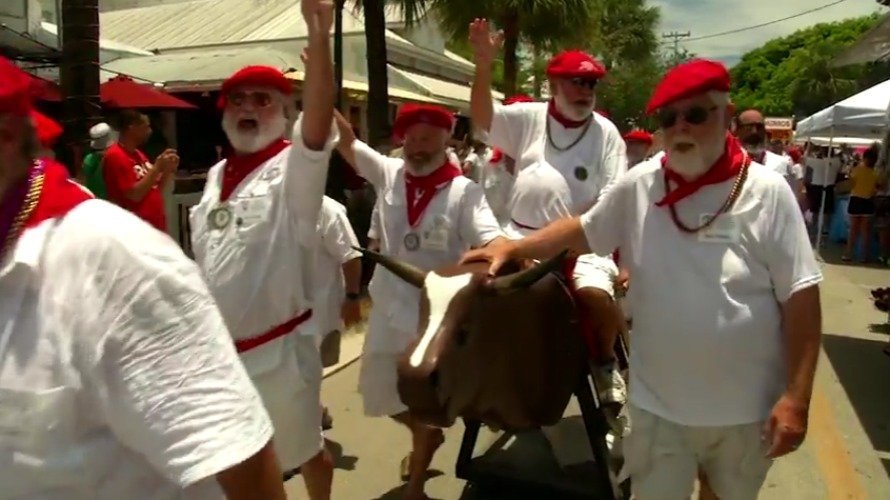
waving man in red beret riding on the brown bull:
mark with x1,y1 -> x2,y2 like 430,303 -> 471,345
470,19 -> 627,418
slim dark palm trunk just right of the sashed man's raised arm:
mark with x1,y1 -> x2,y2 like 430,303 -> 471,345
362,0 -> 390,146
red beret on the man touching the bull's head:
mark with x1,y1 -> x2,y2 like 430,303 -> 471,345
646,59 -> 730,114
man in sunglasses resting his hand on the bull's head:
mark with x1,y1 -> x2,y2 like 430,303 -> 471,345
464,60 -> 822,500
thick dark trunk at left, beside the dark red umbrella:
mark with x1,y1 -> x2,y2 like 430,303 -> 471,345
59,0 -> 101,175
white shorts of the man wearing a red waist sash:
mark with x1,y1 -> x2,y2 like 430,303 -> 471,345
253,333 -> 324,470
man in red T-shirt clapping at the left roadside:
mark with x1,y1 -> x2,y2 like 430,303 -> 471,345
102,110 -> 179,232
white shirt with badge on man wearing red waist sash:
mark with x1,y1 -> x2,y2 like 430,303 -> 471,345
189,116 -> 338,376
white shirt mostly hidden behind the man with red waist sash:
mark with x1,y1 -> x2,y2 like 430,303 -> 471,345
312,196 -> 362,336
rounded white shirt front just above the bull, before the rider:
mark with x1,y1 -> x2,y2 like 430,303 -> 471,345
504,162 -> 572,238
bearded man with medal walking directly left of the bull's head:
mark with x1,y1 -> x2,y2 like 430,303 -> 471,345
336,104 -> 505,500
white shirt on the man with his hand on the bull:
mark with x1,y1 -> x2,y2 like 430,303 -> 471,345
581,161 -> 822,426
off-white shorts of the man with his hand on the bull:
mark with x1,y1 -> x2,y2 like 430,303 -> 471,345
621,405 -> 772,500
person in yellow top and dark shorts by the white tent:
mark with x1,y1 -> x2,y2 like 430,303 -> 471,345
841,144 -> 879,263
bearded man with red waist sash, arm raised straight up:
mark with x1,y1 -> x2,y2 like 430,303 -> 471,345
190,0 -> 337,500
